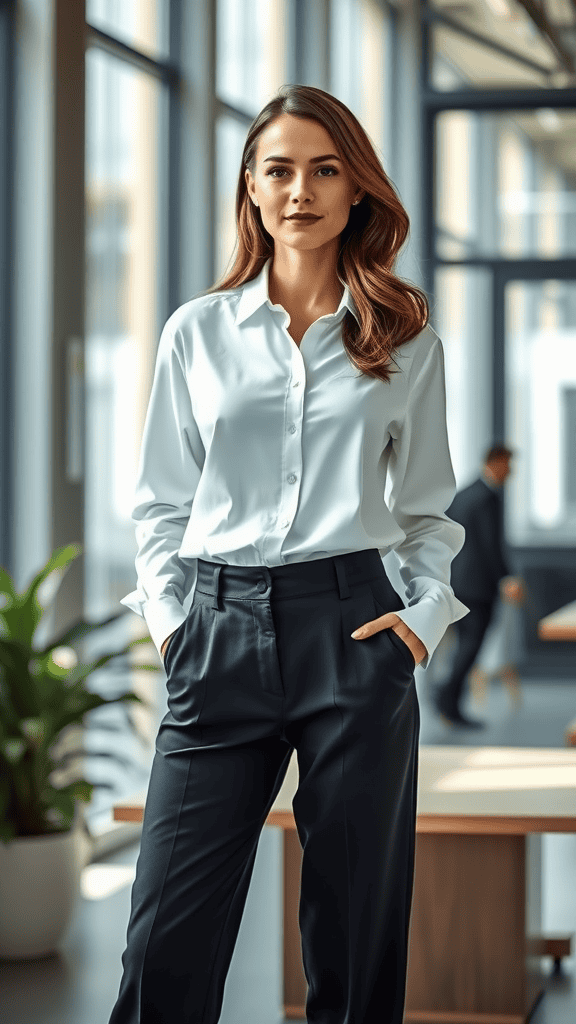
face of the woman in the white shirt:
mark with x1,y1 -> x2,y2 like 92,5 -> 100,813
246,114 -> 361,250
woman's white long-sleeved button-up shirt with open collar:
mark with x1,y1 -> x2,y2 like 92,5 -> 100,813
120,257 -> 468,668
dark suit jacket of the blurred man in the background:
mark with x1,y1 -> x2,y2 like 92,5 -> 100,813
446,477 -> 510,604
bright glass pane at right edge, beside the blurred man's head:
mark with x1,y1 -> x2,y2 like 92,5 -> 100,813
504,279 -> 576,547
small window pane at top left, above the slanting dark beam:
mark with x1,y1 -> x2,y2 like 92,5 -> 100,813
86,0 -> 170,57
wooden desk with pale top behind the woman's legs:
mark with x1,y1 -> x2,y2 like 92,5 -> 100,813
114,746 -> 576,1024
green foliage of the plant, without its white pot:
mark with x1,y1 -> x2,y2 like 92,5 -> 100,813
0,544 -> 158,843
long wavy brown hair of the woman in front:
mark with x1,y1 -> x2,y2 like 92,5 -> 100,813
202,85 -> 429,382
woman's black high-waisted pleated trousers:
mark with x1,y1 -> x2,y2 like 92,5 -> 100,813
110,549 -> 420,1024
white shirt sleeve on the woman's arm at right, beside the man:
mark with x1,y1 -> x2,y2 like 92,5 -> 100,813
388,335 -> 469,669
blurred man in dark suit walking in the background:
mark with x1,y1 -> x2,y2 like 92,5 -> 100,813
433,444 -> 522,728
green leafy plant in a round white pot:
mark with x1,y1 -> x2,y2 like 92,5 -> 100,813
0,544 -> 160,959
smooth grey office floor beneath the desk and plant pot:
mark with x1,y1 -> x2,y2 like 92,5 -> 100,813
0,677 -> 576,1024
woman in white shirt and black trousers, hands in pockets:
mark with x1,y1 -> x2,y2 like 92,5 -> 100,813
110,86 -> 467,1024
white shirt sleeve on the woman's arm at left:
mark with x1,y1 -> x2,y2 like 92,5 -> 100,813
120,319 -> 201,653
